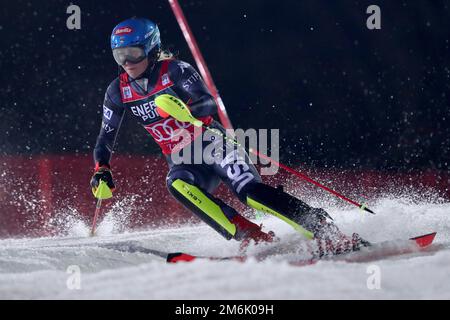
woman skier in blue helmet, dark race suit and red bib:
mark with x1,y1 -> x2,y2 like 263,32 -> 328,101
91,18 -> 363,253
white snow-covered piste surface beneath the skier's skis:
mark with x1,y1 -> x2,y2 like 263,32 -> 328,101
0,199 -> 450,299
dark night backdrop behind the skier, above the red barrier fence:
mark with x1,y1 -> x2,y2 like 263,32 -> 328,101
0,0 -> 450,171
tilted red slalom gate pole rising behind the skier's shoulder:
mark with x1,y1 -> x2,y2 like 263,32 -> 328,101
169,0 -> 233,129
